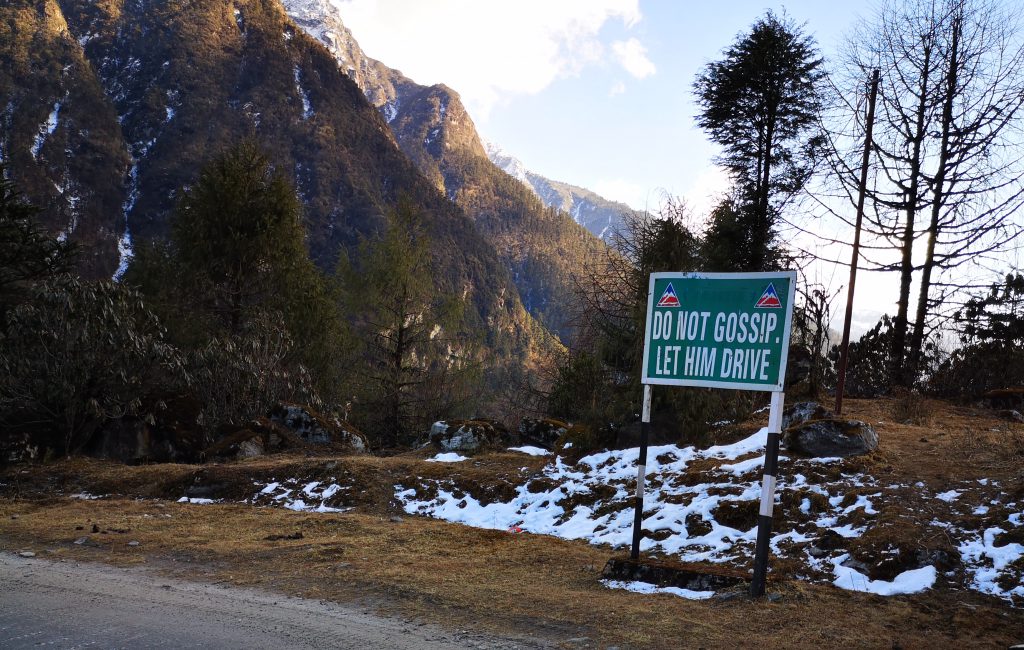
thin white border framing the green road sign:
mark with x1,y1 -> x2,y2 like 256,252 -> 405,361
640,271 -> 797,392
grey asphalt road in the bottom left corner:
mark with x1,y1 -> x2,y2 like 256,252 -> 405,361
0,553 -> 550,650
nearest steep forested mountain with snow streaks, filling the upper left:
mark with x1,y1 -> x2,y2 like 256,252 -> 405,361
0,0 -> 547,368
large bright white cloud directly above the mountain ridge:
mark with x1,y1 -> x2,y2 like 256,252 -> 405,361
332,0 -> 653,120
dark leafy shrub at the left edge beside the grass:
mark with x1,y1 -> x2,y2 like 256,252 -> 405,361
0,275 -> 187,454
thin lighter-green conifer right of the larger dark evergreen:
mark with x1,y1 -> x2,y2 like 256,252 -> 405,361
339,201 -> 475,447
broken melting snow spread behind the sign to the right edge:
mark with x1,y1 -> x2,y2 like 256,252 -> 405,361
395,423 -> 1024,598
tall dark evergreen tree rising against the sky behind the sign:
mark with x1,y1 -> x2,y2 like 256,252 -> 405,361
693,11 -> 824,270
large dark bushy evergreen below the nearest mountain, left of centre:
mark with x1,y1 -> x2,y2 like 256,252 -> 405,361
125,140 -> 344,399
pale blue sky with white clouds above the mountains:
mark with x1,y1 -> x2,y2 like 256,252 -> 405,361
332,0 -> 942,330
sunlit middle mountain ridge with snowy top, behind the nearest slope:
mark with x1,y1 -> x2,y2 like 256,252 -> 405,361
284,0 -> 605,337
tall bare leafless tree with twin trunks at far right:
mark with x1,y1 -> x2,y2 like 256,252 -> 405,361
826,0 -> 1024,382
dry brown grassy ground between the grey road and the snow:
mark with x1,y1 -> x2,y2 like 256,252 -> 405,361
0,400 -> 1024,648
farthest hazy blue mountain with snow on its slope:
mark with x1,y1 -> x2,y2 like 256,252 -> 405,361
484,142 -> 636,242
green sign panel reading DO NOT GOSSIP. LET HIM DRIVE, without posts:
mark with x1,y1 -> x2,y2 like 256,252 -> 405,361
643,271 -> 797,391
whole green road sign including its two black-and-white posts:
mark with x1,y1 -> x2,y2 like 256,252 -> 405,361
630,271 -> 797,596
